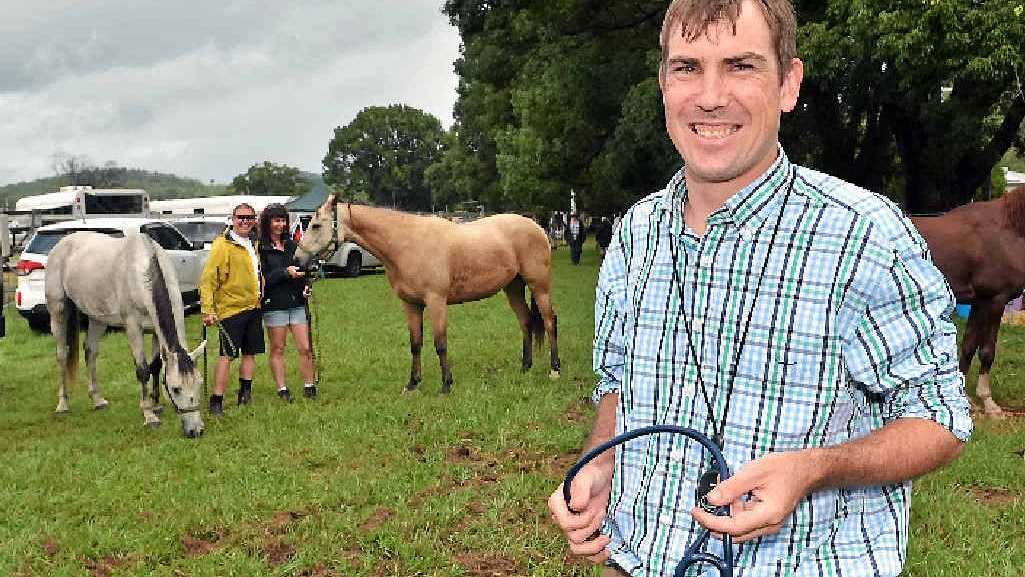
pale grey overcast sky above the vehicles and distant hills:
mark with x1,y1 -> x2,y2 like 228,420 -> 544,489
0,0 -> 459,184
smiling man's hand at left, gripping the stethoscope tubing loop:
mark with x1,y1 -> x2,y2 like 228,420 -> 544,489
548,463 -> 612,563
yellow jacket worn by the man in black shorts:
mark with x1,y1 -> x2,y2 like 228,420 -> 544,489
199,231 -> 261,319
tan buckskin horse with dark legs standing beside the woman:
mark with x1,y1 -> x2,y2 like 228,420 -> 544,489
295,196 -> 560,393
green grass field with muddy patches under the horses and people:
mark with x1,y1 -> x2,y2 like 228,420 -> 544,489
0,248 -> 1025,577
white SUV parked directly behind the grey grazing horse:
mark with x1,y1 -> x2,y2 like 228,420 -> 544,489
14,218 -> 209,332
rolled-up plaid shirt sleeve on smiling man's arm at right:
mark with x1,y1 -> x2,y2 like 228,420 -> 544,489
844,230 -> 973,441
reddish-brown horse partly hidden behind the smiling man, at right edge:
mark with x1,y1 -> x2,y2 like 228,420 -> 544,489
911,187 -> 1025,417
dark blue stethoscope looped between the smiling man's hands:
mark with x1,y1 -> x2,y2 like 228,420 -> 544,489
563,424 -> 733,577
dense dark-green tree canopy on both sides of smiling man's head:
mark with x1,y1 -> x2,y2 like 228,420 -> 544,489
444,0 -> 1025,212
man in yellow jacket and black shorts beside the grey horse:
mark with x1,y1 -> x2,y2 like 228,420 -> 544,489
199,203 -> 263,415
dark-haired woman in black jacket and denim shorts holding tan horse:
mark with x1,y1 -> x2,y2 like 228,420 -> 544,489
259,203 -> 317,402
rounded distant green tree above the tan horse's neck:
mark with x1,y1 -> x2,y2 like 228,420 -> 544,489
324,105 -> 446,210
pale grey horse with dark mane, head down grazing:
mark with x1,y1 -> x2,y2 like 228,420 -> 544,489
46,232 -> 206,438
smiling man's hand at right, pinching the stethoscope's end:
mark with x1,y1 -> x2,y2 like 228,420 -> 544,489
691,451 -> 819,543
